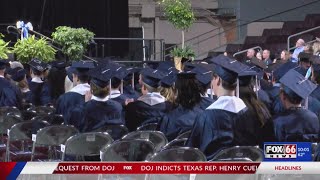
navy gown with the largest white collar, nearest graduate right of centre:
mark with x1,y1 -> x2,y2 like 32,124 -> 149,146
187,96 -> 246,160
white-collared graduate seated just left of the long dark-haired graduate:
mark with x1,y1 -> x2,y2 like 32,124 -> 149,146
125,68 -> 172,131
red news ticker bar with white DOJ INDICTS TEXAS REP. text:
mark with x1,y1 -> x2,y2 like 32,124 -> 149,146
53,162 -> 260,174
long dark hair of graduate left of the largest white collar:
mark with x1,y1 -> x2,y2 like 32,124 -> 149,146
175,76 -> 201,109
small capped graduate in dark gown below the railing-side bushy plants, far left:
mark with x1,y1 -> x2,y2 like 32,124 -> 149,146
26,59 -> 52,106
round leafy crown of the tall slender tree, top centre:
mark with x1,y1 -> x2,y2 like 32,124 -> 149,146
160,0 -> 195,30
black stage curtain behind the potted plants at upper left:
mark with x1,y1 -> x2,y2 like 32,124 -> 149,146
0,0 -> 129,56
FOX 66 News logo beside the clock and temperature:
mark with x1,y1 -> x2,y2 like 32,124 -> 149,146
264,144 -> 297,159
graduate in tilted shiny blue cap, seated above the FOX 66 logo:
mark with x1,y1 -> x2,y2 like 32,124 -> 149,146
274,70 -> 320,142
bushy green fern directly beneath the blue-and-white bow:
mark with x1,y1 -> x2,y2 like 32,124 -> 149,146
13,36 -> 56,63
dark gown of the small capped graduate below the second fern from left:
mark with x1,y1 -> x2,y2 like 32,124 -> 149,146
28,78 -> 51,106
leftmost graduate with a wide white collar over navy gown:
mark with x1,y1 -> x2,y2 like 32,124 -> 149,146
56,61 -> 95,124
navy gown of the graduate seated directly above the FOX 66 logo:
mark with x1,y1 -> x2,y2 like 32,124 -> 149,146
274,108 -> 320,142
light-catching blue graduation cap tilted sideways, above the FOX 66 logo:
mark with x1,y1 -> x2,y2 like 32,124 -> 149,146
280,69 -> 317,99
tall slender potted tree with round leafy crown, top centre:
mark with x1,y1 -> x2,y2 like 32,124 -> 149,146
160,0 -> 195,71
